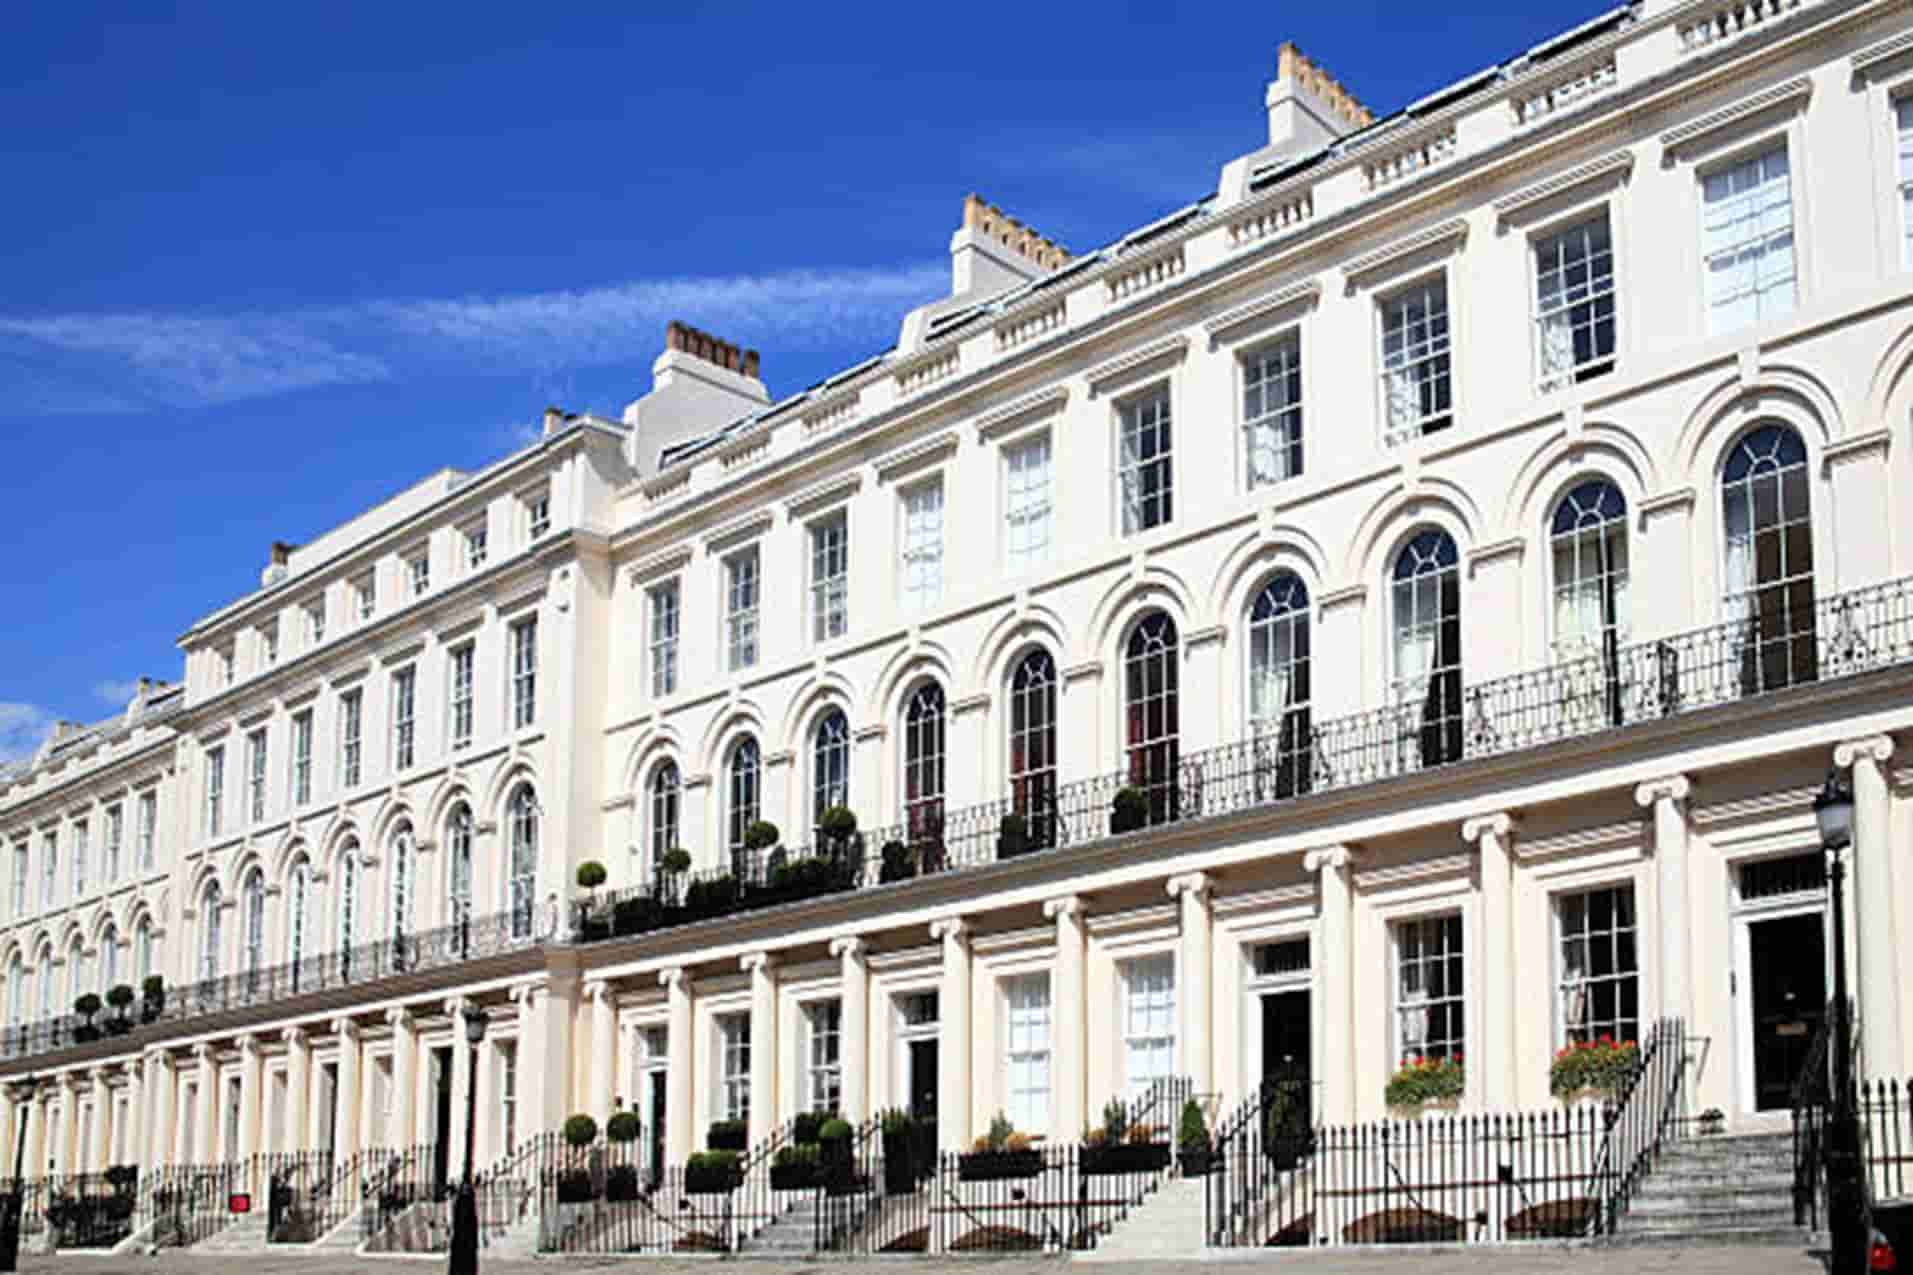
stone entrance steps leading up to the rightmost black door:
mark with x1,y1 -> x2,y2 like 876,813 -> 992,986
1607,1133 -> 1810,1246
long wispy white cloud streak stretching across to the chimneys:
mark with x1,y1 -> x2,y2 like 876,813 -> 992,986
0,262 -> 949,412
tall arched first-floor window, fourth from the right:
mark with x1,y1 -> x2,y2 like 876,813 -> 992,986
1249,572 -> 1312,796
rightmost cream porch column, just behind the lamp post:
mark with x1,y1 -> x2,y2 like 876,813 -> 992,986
1833,735 -> 1900,1076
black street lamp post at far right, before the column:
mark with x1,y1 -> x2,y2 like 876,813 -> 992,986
1814,772 -> 1869,1275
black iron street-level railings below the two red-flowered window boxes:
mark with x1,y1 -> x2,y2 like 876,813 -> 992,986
1190,1018 -> 1685,1248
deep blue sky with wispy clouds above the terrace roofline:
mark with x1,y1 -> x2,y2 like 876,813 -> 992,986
0,0 -> 1605,758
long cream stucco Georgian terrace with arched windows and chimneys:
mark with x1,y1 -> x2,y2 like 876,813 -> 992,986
0,0 -> 1913,1248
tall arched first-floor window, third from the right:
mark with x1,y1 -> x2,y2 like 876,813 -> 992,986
1393,530 -> 1462,766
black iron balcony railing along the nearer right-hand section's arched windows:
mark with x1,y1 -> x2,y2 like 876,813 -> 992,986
572,580 -> 1913,942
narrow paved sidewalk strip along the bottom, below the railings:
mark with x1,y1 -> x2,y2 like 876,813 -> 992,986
19,1246 -> 1825,1275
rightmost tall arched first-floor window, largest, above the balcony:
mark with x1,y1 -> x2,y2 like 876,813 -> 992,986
1720,425 -> 1819,695
